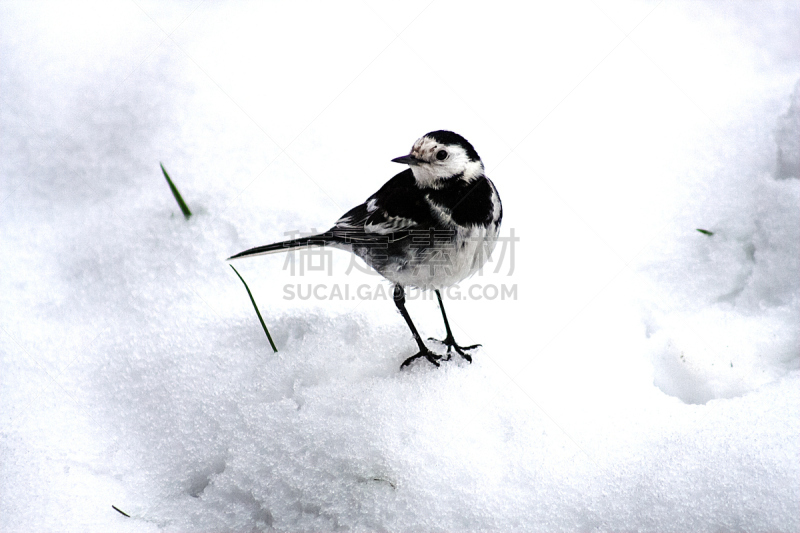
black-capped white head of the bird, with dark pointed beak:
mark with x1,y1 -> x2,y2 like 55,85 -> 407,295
392,130 -> 484,189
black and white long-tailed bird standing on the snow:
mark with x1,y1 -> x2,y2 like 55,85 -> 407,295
228,130 -> 503,368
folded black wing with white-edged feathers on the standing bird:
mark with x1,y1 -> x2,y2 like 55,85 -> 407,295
331,169 -> 435,242
